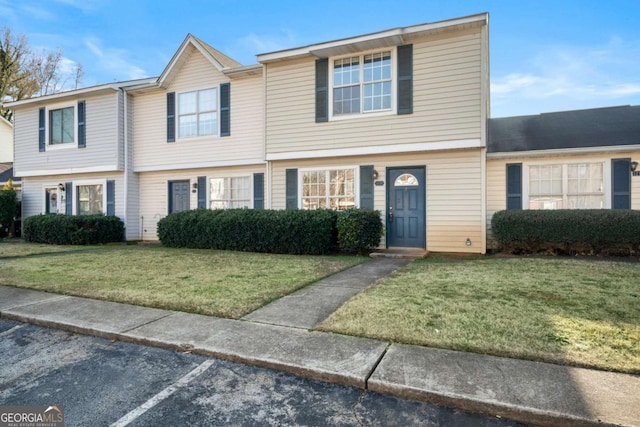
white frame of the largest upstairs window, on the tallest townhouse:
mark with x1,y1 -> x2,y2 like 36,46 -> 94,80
328,47 -> 398,121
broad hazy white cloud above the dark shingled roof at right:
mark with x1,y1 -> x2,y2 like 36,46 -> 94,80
491,38 -> 640,116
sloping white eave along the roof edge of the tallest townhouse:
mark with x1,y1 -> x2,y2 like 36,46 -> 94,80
257,13 -> 489,64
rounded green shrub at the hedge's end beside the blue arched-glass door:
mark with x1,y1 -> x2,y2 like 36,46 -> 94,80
336,209 -> 382,254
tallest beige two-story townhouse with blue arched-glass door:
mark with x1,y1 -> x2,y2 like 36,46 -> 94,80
258,14 -> 489,253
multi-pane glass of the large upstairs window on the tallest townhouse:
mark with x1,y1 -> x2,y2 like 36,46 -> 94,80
330,50 -> 395,117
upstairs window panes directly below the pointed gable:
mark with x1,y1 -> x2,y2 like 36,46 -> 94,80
178,88 -> 218,138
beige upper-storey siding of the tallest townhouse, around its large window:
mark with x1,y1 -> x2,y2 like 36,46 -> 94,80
266,29 -> 482,154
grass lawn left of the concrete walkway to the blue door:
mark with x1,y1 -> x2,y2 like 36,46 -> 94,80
0,246 -> 365,319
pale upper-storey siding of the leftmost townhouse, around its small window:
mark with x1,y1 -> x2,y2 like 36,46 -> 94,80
14,92 -> 122,176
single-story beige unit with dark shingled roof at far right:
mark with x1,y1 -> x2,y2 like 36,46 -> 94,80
487,106 -> 640,246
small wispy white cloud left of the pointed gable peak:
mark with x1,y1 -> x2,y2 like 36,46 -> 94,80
84,38 -> 148,83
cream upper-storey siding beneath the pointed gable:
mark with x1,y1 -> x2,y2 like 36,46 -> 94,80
132,47 -> 264,170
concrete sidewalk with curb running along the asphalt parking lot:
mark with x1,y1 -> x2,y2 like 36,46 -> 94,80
0,286 -> 640,426
